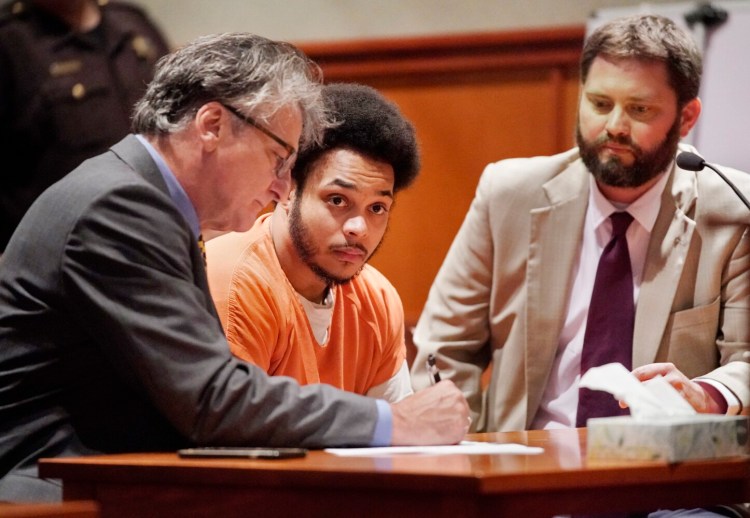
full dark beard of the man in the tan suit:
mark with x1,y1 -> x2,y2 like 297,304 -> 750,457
576,117 -> 680,187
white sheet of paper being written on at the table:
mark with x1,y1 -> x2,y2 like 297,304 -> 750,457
325,441 -> 544,457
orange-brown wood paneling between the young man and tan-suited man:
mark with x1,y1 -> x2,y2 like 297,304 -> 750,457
300,27 -> 584,323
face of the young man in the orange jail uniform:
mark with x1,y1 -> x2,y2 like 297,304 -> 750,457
289,149 -> 394,284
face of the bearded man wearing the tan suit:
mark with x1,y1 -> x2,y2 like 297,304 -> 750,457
577,56 -> 700,187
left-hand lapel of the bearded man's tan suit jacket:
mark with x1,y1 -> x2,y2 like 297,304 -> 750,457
526,160 -> 589,424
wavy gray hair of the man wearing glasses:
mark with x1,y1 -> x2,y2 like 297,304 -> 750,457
132,33 -> 331,147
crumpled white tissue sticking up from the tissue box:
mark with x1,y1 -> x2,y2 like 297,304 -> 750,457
580,363 -> 696,420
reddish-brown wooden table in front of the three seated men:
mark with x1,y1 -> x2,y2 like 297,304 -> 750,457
40,430 -> 750,518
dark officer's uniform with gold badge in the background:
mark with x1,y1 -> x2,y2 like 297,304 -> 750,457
0,0 -> 168,253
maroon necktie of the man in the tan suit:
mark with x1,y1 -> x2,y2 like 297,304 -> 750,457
576,212 -> 635,427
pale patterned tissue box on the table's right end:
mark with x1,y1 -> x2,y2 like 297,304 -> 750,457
586,414 -> 750,462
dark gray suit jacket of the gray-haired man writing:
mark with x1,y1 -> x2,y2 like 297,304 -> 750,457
0,136 -> 377,500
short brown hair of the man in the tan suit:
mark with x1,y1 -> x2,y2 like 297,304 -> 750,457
581,15 -> 703,106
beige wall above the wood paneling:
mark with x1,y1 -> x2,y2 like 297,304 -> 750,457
140,0 -> 688,45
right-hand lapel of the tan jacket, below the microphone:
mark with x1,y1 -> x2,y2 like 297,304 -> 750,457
633,167 -> 696,367
